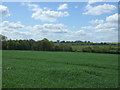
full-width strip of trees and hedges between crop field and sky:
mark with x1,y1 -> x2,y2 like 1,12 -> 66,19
0,35 -> 120,54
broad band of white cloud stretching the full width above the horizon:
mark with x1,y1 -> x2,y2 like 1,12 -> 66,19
0,15 -> 118,42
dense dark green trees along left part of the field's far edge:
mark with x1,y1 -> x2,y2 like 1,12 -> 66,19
2,38 -> 73,51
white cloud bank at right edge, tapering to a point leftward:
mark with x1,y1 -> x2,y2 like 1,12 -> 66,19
81,14 -> 118,32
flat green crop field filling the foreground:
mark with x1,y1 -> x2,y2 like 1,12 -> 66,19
3,50 -> 119,88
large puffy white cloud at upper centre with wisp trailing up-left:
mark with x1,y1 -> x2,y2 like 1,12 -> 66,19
24,3 -> 69,22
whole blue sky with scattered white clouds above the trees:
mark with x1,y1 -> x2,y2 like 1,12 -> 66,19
0,0 -> 118,42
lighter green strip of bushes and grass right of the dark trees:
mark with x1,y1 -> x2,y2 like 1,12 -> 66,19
72,45 -> 120,54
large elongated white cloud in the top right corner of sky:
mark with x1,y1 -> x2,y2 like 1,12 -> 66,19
83,4 -> 116,15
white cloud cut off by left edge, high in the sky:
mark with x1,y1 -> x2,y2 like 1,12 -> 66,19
0,5 -> 10,18
